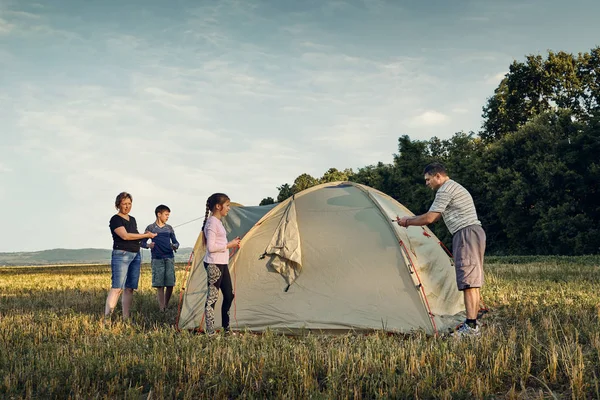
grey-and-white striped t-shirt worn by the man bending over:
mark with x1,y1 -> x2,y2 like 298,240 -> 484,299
429,179 -> 481,235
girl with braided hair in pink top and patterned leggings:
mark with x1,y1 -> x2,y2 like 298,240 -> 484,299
202,193 -> 240,334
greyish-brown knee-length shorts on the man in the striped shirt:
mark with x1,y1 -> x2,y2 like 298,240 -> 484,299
452,225 -> 486,290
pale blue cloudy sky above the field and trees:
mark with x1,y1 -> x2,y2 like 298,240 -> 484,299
0,0 -> 600,252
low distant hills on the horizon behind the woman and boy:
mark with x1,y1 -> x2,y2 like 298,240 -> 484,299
0,247 -> 192,266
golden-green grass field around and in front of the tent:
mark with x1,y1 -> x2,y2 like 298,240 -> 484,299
0,256 -> 600,399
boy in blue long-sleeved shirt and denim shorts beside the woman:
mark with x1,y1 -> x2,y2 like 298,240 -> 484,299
142,204 -> 179,311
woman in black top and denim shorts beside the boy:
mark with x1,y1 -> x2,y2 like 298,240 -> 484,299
104,192 -> 156,319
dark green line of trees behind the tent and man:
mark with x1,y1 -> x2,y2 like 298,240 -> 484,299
261,47 -> 600,255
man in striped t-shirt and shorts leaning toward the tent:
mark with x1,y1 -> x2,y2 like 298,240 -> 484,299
398,163 -> 486,336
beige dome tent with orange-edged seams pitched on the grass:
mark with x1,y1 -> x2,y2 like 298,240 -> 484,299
177,182 -> 464,334
